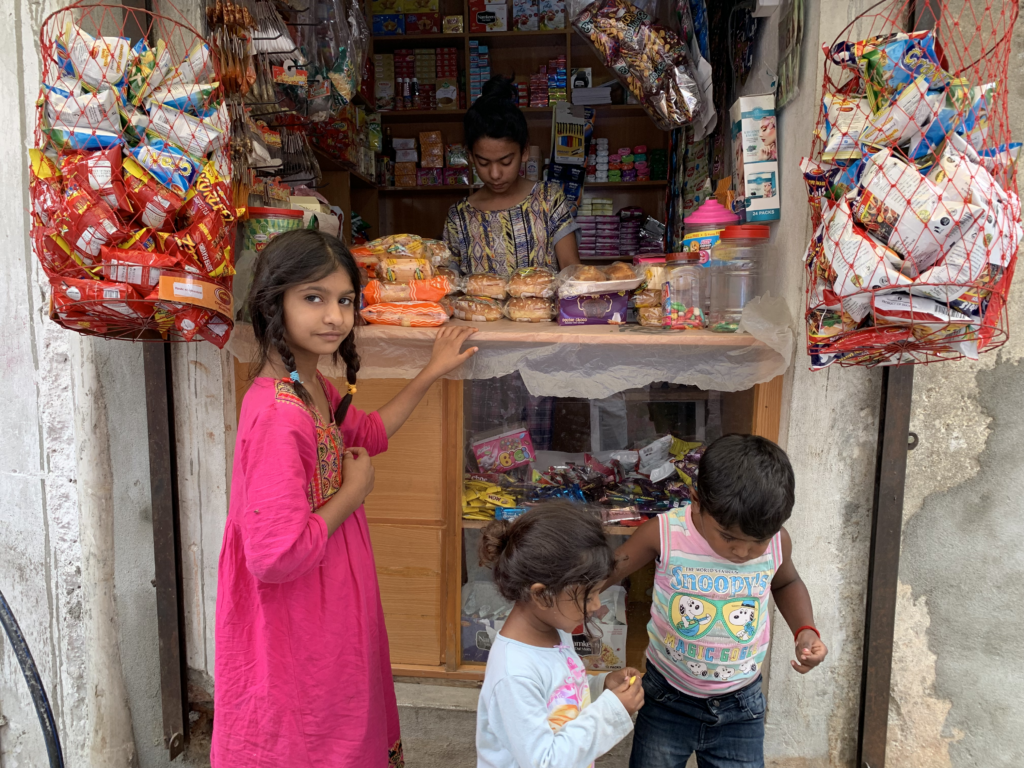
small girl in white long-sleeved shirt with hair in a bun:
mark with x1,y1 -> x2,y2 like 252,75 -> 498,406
476,502 -> 643,768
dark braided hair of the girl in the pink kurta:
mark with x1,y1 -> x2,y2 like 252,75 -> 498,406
246,229 -> 361,424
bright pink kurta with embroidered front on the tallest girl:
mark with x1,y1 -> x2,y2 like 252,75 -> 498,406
210,378 -> 401,768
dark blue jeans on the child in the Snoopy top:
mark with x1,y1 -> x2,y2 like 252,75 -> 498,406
630,664 -> 765,768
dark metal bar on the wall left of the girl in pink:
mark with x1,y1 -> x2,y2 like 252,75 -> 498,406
142,343 -> 188,760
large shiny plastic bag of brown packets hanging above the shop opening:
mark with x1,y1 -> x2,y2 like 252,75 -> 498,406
572,0 -> 708,130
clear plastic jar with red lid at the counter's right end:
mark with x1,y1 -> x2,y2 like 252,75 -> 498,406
708,224 -> 770,333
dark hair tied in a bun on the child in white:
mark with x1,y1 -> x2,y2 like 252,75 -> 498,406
480,501 -> 614,626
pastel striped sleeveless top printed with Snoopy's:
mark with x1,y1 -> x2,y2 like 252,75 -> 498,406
647,504 -> 782,698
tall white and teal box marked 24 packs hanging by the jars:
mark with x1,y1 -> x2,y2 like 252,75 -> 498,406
729,93 -> 781,222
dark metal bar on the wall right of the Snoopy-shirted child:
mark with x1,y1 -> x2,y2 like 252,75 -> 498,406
857,366 -> 914,768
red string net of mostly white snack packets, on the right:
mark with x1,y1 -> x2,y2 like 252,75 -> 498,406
801,0 -> 1022,369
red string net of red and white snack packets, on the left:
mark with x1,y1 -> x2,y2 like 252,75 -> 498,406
30,5 -> 237,346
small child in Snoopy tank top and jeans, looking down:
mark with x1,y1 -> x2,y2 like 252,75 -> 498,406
605,435 -> 828,768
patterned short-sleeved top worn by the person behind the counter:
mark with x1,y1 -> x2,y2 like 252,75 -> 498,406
444,181 -> 579,278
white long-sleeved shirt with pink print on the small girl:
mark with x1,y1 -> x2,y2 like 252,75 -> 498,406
476,632 -> 633,768
